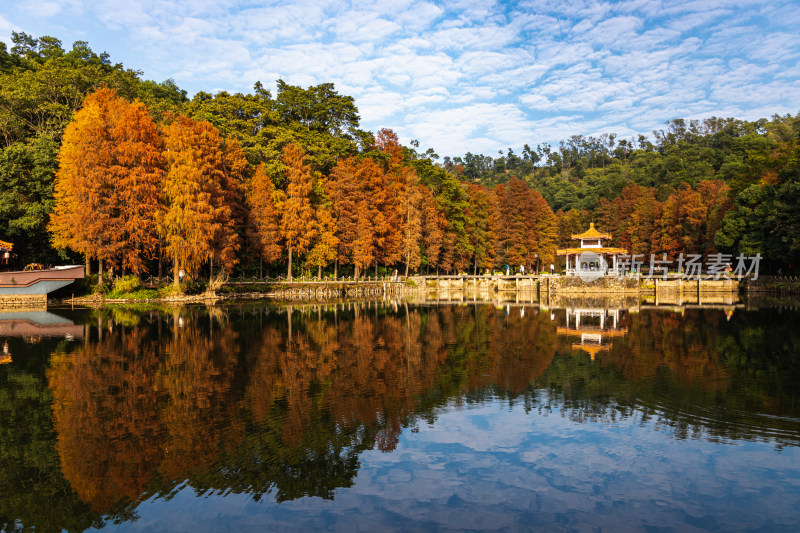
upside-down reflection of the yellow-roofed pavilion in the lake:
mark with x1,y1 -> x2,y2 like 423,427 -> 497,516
556,308 -> 628,361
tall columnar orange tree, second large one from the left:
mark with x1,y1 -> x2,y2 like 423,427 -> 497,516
158,115 -> 239,287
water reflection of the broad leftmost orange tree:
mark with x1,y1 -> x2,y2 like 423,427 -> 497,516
47,328 -> 163,511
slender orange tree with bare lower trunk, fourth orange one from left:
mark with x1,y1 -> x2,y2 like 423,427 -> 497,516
280,144 -> 314,280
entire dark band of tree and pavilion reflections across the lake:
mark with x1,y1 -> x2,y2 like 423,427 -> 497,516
0,300 -> 800,529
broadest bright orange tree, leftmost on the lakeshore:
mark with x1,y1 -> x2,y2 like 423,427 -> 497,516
49,88 -> 164,283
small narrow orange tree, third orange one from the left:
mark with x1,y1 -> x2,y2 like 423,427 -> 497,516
247,163 -> 281,276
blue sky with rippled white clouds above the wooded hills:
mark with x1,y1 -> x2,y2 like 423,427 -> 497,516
0,0 -> 800,155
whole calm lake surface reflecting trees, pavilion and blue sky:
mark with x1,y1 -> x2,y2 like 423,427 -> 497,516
0,301 -> 800,532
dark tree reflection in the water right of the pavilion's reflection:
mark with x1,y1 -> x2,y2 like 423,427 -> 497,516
534,309 -> 800,444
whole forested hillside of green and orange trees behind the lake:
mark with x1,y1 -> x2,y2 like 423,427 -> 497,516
0,33 -> 800,276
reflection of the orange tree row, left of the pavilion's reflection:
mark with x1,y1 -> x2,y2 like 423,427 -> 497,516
42,304 -> 554,511
